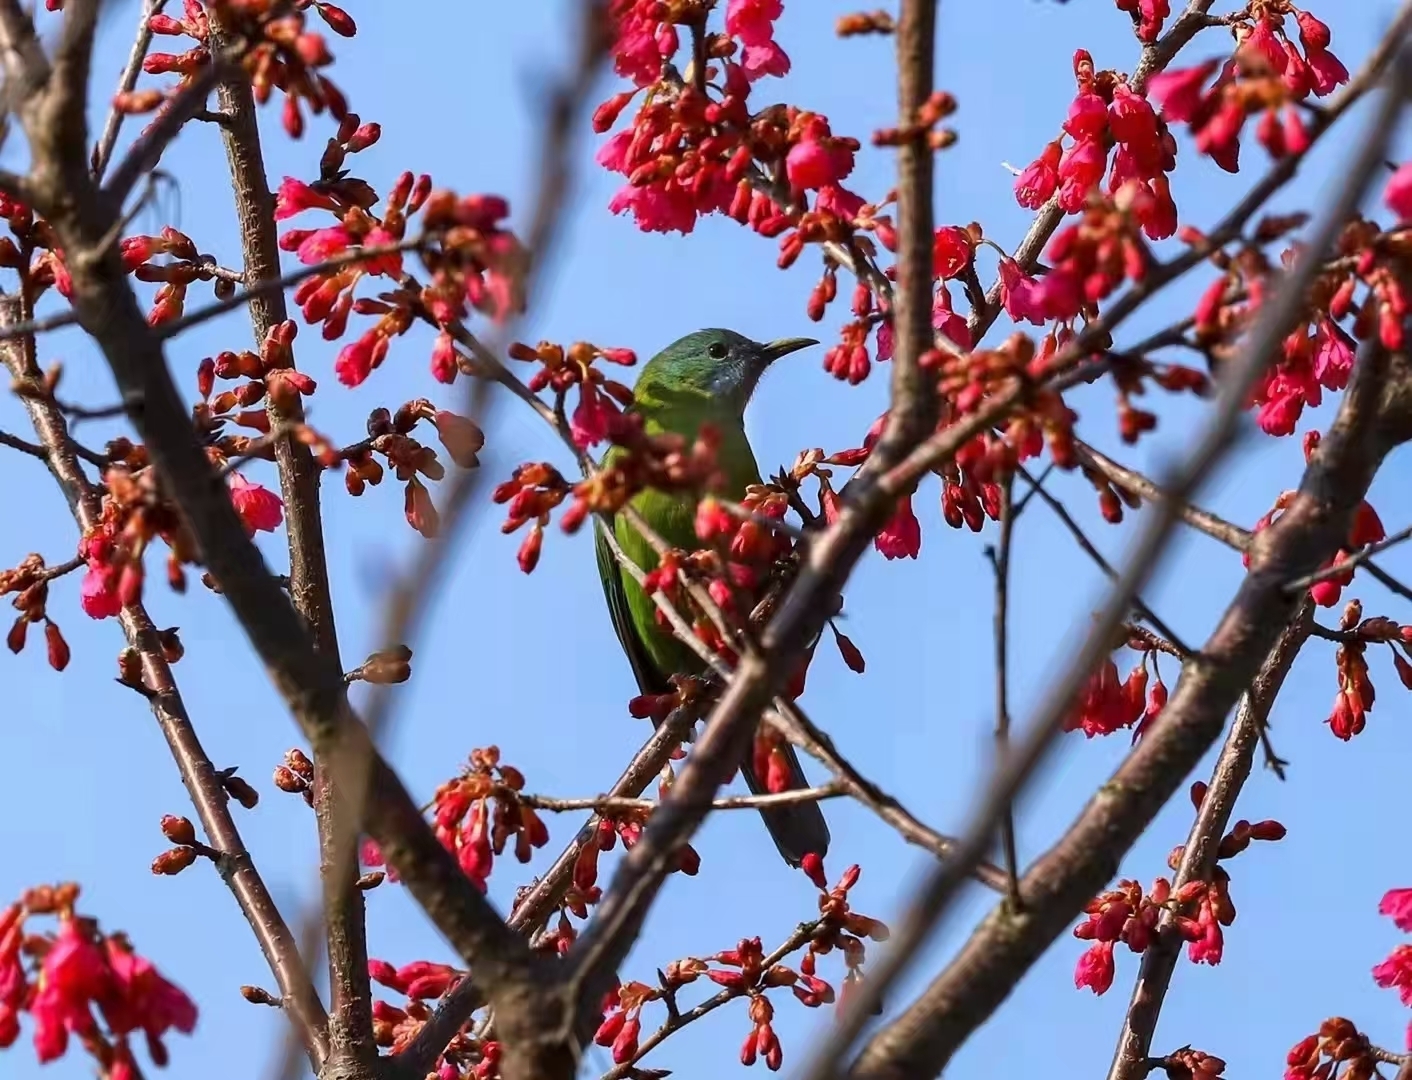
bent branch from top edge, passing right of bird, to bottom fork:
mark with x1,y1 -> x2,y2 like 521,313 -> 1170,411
569,0 -> 939,1032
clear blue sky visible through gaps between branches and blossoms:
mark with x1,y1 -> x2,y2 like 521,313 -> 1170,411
0,0 -> 1412,1080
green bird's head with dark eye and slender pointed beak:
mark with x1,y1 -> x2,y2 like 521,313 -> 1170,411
635,330 -> 818,415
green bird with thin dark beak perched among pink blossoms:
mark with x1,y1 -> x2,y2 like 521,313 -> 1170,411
594,329 -> 829,867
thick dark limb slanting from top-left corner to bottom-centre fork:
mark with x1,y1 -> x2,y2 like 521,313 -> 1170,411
0,14 -> 562,1080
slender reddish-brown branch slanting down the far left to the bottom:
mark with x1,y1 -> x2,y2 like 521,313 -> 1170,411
0,296 -> 329,1070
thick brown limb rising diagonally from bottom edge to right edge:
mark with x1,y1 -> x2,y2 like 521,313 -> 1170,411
850,337 -> 1412,1080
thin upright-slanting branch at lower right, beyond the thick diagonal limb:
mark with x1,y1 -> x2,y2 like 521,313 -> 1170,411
1108,597 -> 1313,1080
